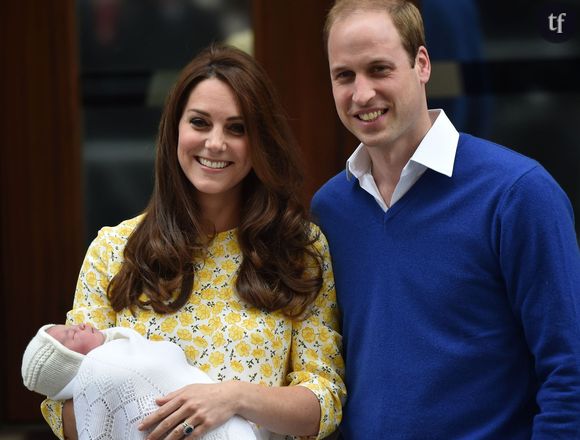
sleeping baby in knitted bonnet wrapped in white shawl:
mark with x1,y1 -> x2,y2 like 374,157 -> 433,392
22,324 -> 256,440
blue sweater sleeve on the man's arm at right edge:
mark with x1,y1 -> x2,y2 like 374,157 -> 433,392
496,166 -> 580,440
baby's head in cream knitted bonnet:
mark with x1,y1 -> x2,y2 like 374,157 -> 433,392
22,324 -> 105,397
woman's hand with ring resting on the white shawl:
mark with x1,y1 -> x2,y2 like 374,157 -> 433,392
139,382 -> 239,440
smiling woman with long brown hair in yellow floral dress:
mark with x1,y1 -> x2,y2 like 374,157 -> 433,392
42,46 -> 345,440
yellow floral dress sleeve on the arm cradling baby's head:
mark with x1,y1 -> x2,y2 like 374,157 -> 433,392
40,228 -> 125,440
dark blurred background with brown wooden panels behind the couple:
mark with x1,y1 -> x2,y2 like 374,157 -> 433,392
0,0 -> 580,440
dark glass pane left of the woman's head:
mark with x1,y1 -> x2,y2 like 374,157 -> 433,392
77,0 -> 253,244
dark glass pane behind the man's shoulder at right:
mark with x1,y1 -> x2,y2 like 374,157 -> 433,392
421,0 -> 580,237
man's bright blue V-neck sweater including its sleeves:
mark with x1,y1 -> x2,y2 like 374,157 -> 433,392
312,134 -> 580,440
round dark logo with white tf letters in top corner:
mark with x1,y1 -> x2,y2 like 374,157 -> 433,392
537,2 -> 577,43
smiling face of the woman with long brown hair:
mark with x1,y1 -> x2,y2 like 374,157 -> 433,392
177,78 -> 252,205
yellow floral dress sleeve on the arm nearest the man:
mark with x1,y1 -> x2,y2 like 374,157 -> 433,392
287,228 -> 346,439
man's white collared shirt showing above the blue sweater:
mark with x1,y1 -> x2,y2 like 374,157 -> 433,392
346,109 -> 459,212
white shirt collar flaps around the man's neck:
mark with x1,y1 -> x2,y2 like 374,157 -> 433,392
346,109 -> 459,180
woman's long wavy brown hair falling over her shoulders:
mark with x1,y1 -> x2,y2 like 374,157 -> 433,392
108,45 -> 322,318
